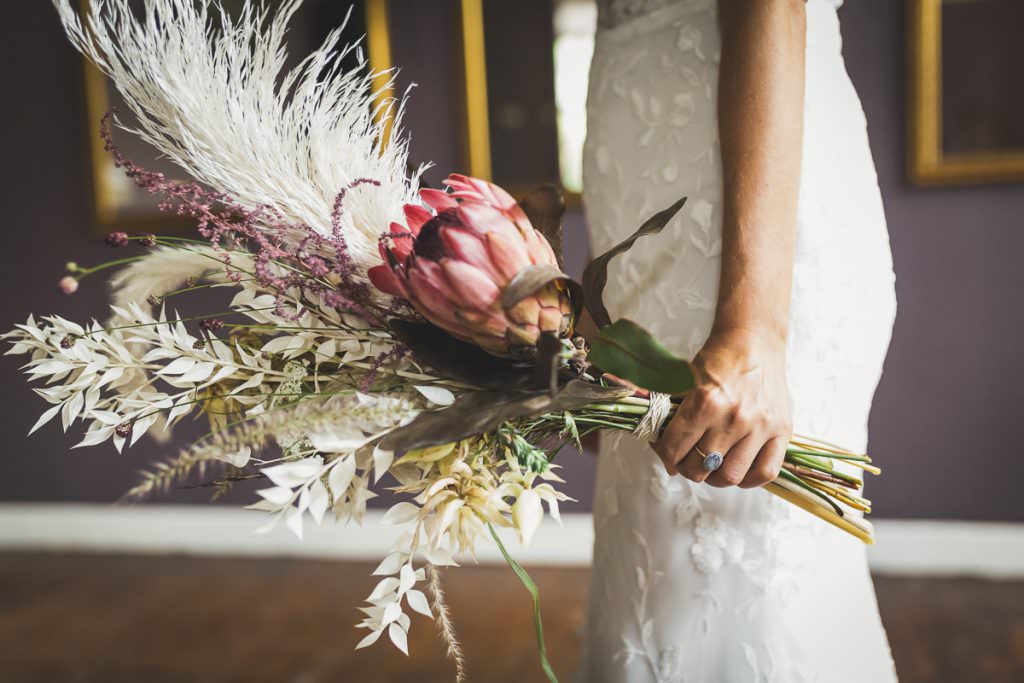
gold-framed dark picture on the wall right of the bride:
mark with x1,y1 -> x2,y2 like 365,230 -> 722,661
907,0 -> 1024,185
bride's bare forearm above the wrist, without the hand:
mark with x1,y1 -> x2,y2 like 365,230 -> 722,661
713,0 -> 806,350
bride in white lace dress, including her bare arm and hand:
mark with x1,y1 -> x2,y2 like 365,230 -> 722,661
581,0 -> 896,683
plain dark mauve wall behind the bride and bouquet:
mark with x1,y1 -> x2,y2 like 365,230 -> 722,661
0,0 -> 1024,521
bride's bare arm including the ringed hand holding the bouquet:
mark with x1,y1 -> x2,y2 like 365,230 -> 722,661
654,0 -> 806,486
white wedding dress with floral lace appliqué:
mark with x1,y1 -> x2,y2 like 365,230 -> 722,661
579,0 -> 896,683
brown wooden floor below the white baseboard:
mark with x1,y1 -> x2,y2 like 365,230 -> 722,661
0,554 -> 1024,683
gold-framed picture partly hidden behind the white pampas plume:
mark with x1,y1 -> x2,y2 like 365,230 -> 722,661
81,0 -> 368,233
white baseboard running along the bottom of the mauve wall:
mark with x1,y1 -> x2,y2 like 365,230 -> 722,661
0,503 -> 1024,579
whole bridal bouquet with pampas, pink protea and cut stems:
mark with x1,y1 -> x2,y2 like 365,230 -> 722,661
5,0 -> 878,679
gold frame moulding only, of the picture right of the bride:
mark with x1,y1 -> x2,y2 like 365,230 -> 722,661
907,0 -> 1024,185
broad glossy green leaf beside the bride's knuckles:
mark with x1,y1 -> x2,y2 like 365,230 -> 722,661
589,318 -> 695,393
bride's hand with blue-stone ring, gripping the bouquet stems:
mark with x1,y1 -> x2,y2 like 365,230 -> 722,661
653,334 -> 792,488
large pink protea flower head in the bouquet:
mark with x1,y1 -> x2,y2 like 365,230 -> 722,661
369,174 -> 572,358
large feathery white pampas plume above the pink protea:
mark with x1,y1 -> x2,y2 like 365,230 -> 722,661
52,0 -> 423,270
